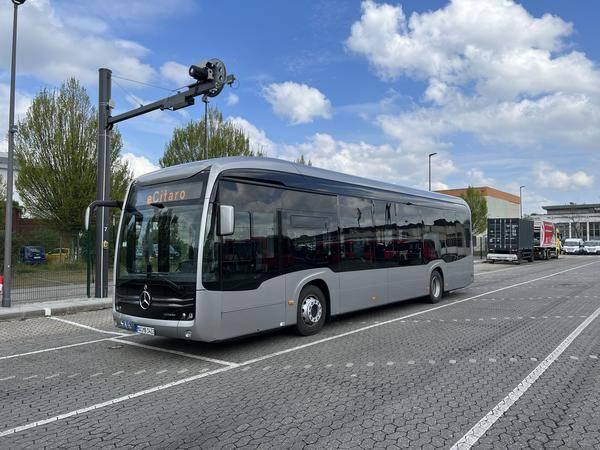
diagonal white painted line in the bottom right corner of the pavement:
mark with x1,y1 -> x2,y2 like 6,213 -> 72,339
452,300 -> 600,449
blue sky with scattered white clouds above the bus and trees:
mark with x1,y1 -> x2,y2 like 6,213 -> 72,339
0,0 -> 600,211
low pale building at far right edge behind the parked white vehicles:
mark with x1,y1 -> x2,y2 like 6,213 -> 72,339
533,203 -> 600,241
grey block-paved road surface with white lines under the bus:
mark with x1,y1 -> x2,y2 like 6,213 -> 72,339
0,257 -> 600,449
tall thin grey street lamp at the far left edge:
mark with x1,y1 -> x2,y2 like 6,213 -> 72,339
2,0 -> 25,308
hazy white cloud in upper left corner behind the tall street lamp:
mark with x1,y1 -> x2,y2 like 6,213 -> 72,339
0,0 -> 156,84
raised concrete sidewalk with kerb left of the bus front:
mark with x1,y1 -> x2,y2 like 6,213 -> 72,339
0,297 -> 112,321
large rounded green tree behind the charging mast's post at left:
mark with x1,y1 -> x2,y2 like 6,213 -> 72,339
15,78 -> 132,232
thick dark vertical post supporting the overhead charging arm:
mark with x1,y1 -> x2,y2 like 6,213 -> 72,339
94,69 -> 112,298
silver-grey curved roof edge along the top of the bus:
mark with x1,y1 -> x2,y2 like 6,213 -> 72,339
136,156 -> 467,206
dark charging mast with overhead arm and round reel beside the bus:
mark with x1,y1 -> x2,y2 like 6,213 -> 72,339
92,59 -> 235,298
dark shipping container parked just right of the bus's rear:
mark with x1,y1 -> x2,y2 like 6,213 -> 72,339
487,218 -> 534,264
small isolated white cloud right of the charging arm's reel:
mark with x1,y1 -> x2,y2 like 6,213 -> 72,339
263,81 -> 331,125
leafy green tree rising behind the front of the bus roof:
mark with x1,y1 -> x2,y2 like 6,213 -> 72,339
159,107 -> 263,167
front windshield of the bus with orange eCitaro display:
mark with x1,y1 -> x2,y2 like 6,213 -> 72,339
117,177 -> 205,287
